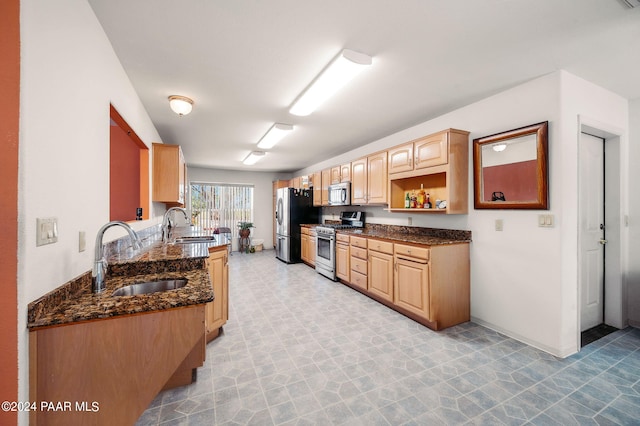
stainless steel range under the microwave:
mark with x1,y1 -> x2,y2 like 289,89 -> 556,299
316,212 -> 364,281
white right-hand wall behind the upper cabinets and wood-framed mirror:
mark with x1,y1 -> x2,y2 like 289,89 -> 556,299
296,72 -> 628,356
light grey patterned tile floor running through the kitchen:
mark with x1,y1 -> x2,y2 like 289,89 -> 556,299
137,250 -> 640,425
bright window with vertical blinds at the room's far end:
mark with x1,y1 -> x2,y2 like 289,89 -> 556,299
189,182 -> 253,237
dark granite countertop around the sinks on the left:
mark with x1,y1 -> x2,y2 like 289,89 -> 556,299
27,227 -> 227,330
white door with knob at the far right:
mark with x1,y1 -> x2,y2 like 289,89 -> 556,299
579,133 -> 605,331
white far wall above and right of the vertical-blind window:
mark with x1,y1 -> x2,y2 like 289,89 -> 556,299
189,167 -> 291,250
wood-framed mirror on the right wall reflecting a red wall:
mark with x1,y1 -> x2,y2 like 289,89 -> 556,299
473,121 -> 549,210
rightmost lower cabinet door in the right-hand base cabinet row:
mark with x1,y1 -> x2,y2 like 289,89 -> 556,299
393,257 -> 431,320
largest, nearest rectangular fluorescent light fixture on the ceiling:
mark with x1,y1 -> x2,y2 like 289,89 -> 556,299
289,49 -> 372,116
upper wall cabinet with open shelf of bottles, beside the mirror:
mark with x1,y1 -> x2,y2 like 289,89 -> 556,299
388,129 -> 469,214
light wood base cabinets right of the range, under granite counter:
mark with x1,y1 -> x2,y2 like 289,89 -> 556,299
336,236 -> 471,330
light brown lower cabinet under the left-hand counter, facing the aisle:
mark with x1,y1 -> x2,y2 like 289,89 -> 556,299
205,246 -> 229,342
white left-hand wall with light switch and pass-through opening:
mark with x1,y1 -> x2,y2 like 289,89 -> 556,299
18,0 -> 163,424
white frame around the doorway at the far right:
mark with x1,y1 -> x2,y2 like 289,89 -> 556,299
576,115 -> 628,350
